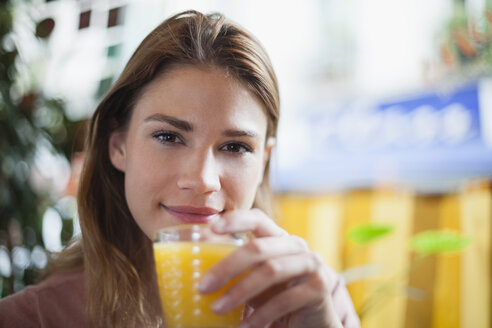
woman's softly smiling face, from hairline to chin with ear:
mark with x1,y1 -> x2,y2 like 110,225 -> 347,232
109,66 -> 274,238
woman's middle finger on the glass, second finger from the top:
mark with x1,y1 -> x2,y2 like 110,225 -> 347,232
198,235 -> 308,293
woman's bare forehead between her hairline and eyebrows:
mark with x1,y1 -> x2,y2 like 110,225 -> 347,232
134,66 -> 267,130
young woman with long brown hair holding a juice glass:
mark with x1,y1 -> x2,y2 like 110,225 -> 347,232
0,11 -> 359,328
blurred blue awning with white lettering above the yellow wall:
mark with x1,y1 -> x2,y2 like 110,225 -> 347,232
273,79 -> 492,191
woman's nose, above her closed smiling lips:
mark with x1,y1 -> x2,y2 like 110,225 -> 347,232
178,151 -> 221,193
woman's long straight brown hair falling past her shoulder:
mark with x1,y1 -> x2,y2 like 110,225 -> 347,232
50,11 -> 280,327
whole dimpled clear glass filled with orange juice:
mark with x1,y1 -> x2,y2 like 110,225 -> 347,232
154,224 -> 248,328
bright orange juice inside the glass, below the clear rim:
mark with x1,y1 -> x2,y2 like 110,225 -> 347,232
154,241 -> 243,328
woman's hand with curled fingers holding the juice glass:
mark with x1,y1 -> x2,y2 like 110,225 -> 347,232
199,209 -> 342,328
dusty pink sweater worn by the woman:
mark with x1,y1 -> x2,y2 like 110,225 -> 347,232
0,271 -> 360,328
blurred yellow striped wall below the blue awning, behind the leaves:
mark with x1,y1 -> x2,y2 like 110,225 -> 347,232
278,182 -> 492,328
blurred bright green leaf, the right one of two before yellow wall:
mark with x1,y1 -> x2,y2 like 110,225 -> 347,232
410,230 -> 471,255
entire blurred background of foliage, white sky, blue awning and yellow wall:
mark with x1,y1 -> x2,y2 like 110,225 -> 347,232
0,0 -> 492,328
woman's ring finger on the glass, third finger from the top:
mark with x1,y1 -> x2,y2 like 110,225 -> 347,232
212,253 -> 323,314
